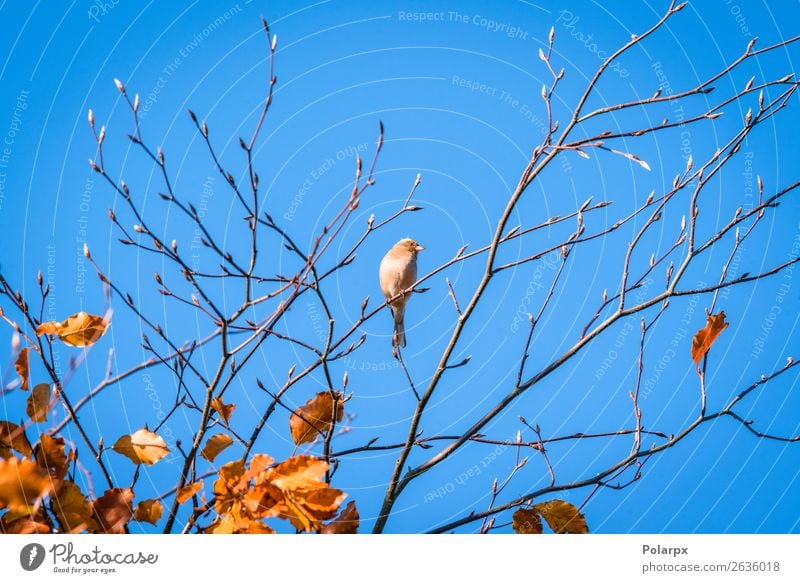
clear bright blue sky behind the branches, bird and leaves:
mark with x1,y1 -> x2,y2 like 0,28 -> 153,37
0,0 -> 800,533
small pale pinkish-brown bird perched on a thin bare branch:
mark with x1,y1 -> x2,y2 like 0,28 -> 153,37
380,238 -> 425,346
